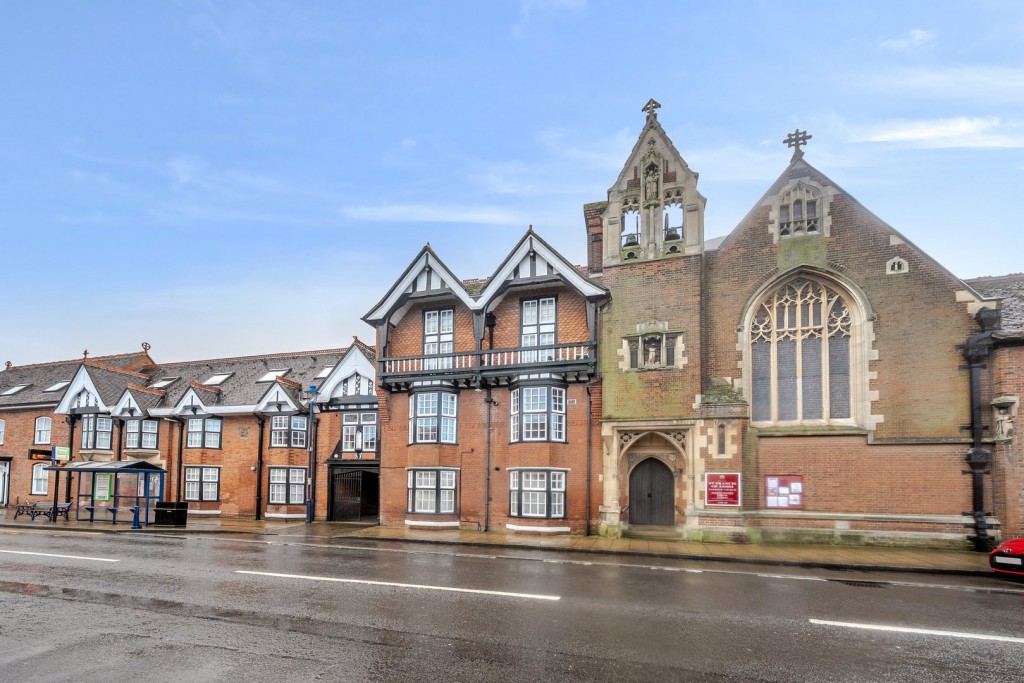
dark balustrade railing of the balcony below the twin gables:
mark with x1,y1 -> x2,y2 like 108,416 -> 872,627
380,343 -> 595,377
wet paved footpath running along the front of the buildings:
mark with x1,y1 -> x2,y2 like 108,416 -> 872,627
0,508 -> 992,577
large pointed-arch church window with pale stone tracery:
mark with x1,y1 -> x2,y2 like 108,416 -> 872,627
750,278 -> 854,424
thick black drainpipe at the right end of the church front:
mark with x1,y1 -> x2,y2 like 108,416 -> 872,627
963,308 -> 999,552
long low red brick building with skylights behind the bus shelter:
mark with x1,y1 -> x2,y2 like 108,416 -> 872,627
0,340 -> 379,521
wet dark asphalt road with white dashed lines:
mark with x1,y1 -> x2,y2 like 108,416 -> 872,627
0,529 -> 1024,683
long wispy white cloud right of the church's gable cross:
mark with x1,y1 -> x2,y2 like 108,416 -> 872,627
854,117 -> 1024,148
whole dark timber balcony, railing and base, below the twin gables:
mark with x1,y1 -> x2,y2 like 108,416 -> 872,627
378,342 -> 597,391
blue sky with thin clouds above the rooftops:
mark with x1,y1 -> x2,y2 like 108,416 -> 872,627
0,0 -> 1024,365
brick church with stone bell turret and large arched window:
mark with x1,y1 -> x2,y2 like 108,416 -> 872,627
584,100 -> 1007,545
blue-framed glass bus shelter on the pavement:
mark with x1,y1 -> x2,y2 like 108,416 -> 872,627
46,460 -> 167,528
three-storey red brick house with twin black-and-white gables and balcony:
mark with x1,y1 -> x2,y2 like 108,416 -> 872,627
364,229 -> 607,533
